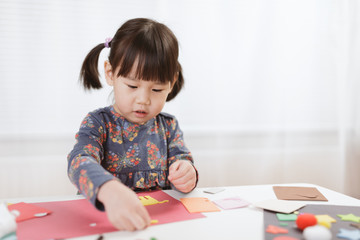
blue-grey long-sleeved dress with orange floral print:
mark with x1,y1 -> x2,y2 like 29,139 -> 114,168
68,106 -> 197,209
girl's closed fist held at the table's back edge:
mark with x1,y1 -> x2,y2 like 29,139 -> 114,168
168,160 -> 196,193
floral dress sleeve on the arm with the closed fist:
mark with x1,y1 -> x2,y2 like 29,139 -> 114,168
166,118 -> 199,188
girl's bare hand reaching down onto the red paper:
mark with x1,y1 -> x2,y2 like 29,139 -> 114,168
97,180 -> 151,231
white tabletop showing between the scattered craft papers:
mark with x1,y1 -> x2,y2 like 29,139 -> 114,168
2,183 -> 360,240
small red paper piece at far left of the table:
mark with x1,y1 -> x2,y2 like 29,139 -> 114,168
8,202 -> 51,222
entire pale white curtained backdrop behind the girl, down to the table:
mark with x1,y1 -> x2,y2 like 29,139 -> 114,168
0,0 -> 360,197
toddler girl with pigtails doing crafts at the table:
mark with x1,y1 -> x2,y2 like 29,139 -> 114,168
68,18 -> 198,231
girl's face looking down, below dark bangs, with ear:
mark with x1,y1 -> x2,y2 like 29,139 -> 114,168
105,61 -> 171,124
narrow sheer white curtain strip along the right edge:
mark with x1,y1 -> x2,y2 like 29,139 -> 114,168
337,1 -> 360,198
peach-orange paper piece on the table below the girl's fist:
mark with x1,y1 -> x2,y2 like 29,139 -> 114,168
180,197 -> 220,213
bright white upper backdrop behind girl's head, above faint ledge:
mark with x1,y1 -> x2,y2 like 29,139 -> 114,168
0,0 -> 339,138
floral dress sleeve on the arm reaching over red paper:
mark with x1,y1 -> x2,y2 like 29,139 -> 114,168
67,114 -> 115,210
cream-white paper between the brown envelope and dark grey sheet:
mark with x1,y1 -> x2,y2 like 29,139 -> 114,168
253,199 -> 305,213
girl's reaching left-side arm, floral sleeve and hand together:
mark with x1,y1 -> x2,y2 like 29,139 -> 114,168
68,114 -> 150,231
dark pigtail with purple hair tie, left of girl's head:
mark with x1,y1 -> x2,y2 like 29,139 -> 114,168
79,43 -> 105,90
